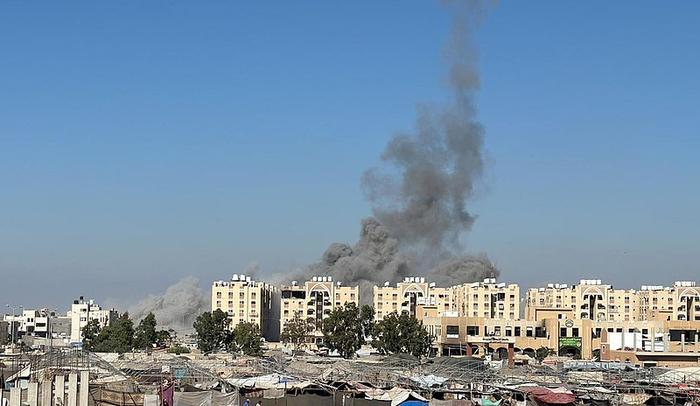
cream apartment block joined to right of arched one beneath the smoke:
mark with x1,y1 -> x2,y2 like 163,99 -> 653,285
452,278 -> 520,320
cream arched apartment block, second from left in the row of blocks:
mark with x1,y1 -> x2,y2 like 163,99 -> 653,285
280,276 -> 360,344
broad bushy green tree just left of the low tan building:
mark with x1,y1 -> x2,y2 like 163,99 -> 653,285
372,312 -> 433,358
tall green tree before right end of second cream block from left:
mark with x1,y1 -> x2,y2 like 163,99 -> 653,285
322,303 -> 365,358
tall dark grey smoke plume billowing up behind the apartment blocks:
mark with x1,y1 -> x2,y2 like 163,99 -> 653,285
296,1 -> 499,303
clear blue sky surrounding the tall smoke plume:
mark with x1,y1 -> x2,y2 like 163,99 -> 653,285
0,1 -> 700,307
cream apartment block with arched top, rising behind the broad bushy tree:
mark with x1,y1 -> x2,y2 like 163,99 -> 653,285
373,276 -> 455,320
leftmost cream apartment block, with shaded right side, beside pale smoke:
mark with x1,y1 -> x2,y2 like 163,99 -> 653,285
211,274 -> 279,341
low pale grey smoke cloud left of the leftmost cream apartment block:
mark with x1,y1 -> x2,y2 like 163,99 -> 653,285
129,276 -> 211,332
